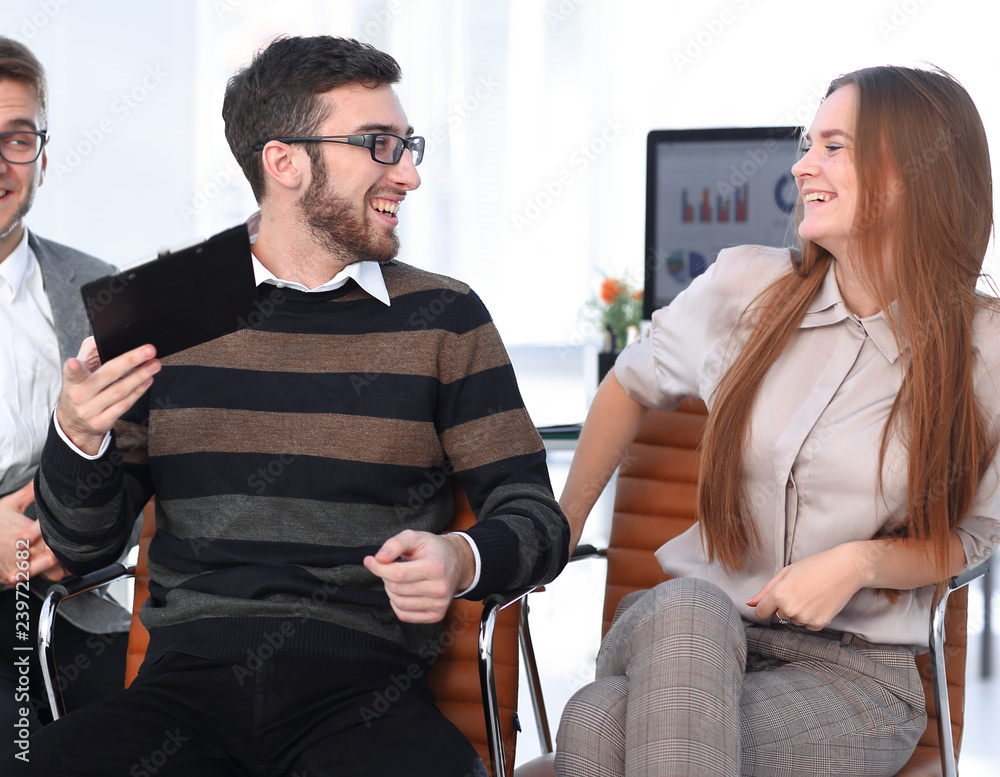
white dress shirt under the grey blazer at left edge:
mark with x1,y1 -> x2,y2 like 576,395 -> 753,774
0,229 -> 62,494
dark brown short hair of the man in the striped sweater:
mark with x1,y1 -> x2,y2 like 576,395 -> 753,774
222,35 -> 401,202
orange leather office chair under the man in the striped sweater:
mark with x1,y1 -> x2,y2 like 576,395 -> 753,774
38,488 -> 525,777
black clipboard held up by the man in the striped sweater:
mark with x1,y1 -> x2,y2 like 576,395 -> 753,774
80,224 -> 257,364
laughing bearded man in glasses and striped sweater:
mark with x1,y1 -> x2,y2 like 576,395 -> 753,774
23,36 -> 568,777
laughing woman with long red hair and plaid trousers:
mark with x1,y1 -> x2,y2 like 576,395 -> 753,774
556,67 -> 1000,777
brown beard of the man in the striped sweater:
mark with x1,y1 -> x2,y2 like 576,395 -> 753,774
299,155 -> 399,264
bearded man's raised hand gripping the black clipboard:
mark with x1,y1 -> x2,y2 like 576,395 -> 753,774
56,337 -> 161,455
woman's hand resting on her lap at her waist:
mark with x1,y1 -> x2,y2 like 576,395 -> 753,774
747,543 -> 867,631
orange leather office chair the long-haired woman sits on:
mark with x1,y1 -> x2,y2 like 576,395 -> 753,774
515,400 -> 984,777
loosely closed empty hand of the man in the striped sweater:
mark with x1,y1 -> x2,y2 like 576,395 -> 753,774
365,529 -> 476,623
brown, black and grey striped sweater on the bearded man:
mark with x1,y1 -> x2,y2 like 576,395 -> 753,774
37,262 -> 568,661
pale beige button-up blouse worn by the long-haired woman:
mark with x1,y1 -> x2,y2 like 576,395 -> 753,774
615,246 -> 1000,647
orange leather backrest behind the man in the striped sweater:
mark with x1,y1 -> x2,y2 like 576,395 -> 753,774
125,487 -> 520,777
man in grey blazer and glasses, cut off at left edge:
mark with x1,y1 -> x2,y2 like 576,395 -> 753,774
0,37 -> 135,753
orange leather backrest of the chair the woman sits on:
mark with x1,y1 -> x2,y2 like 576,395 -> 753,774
602,400 -> 968,777
